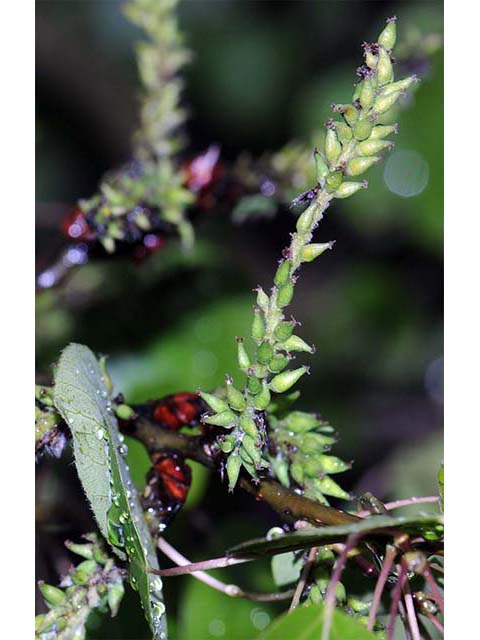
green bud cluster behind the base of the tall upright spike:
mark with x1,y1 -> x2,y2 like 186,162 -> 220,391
269,411 -> 351,505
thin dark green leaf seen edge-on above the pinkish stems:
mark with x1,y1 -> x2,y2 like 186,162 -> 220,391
227,514 -> 443,558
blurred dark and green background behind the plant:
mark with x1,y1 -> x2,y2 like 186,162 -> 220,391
36,0 -> 443,640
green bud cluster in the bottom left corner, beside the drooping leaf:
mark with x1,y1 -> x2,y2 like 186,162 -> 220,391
35,534 -> 124,640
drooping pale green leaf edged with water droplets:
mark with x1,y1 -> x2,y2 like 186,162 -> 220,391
54,344 -> 166,640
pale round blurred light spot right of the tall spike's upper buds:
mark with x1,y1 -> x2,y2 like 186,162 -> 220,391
383,149 -> 430,198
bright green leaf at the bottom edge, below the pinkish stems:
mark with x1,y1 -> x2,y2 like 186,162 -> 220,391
256,604 -> 376,640
